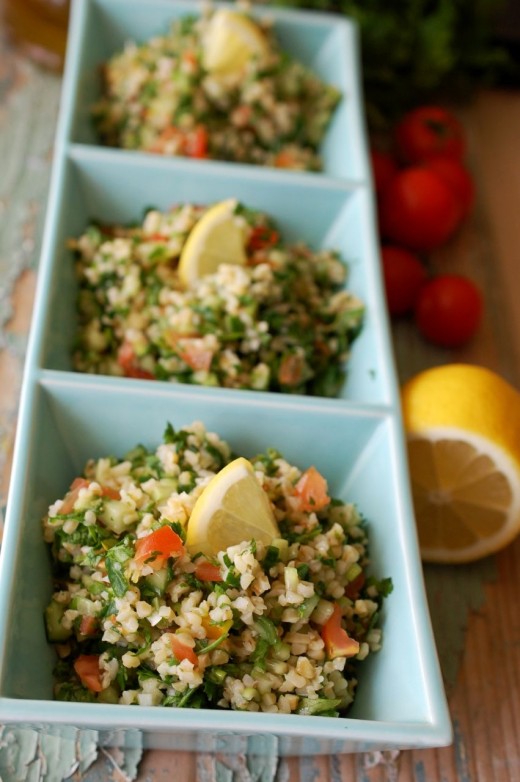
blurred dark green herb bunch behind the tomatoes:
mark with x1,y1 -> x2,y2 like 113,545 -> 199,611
271,0 -> 517,130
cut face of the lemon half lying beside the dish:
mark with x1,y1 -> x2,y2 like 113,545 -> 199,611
408,429 -> 520,562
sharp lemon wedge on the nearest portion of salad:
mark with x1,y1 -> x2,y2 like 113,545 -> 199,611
186,457 -> 280,557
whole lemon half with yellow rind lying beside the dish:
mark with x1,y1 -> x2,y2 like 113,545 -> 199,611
401,364 -> 520,562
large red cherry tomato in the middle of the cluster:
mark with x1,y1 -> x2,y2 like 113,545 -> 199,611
379,166 -> 460,251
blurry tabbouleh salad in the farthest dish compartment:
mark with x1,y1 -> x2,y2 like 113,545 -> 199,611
92,5 -> 340,170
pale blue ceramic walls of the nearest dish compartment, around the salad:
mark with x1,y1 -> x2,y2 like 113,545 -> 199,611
0,373 -> 450,754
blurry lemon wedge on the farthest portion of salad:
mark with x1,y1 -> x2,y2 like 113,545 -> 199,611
203,8 -> 268,76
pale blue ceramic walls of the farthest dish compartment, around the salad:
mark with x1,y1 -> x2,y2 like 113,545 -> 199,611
61,0 -> 369,181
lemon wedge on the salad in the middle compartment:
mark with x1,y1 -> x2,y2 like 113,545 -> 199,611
178,198 -> 247,287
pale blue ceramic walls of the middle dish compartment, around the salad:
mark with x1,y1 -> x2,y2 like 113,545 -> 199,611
34,146 -> 394,404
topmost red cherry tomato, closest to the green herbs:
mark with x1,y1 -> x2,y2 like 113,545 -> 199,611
394,106 -> 466,163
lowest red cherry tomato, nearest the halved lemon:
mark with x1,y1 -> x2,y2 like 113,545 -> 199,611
415,274 -> 483,348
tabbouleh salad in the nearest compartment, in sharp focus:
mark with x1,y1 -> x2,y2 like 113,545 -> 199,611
43,422 -> 391,716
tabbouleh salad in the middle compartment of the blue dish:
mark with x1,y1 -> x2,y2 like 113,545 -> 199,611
70,204 -> 363,397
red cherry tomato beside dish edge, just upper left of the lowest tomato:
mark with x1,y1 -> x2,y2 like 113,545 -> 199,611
381,244 -> 426,315
